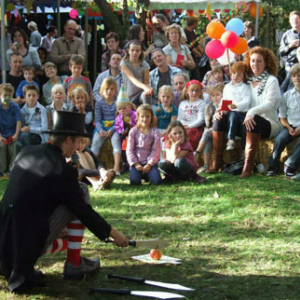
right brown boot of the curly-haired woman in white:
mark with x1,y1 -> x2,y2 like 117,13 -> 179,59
241,132 -> 260,178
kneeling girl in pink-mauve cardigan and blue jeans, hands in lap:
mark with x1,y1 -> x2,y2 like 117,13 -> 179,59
126,104 -> 161,185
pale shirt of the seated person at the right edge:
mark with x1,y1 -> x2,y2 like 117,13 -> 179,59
279,88 -> 300,127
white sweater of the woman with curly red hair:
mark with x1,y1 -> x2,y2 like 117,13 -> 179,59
246,75 -> 282,137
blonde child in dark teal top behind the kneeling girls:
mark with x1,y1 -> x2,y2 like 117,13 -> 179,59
154,85 -> 178,157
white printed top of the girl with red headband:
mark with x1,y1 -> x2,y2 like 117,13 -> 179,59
177,99 -> 206,128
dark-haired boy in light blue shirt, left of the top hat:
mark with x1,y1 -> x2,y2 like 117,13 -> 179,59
17,84 -> 48,152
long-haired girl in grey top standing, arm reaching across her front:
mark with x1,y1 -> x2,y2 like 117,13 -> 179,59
121,40 -> 153,106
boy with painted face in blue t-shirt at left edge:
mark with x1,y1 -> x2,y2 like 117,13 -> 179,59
0,83 -> 21,176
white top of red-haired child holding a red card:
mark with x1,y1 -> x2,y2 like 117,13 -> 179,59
223,81 -> 251,112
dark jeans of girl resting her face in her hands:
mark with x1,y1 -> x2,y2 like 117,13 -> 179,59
158,158 -> 193,179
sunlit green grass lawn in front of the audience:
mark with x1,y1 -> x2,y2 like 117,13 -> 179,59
0,174 -> 300,300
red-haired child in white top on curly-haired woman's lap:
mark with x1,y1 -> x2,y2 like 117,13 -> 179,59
221,61 -> 251,150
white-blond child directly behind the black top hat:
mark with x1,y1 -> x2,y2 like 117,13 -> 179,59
46,84 -> 68,128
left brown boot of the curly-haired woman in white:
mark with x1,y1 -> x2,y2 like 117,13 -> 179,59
207,131 -> 225,173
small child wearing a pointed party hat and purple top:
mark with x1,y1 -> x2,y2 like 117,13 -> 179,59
115,85 -> 136,173
